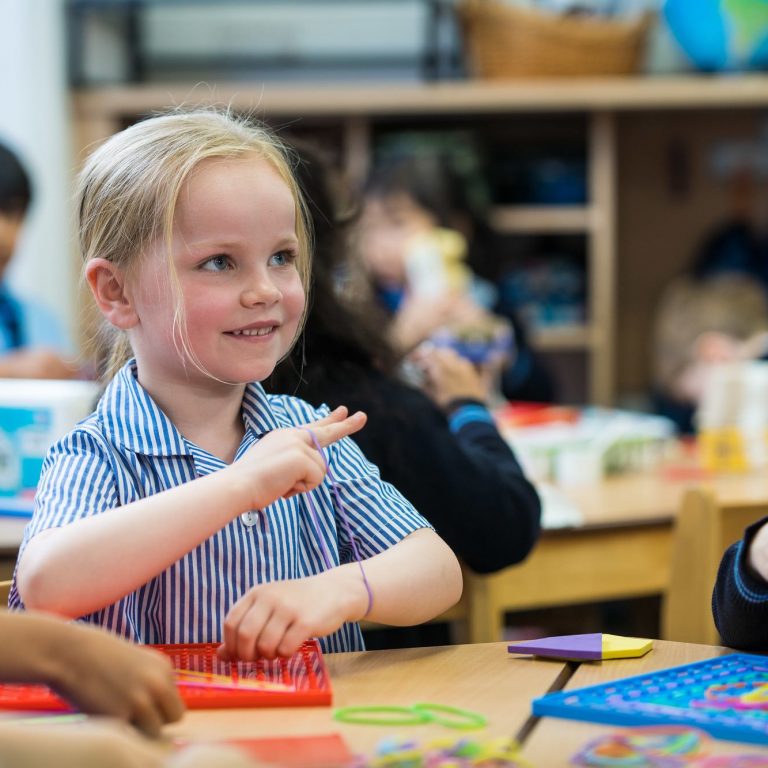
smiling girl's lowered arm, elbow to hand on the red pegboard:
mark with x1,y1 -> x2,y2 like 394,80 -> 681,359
220,528 -> 462,660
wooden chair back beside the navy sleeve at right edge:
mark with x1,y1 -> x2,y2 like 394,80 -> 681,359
662,488 -> 768,645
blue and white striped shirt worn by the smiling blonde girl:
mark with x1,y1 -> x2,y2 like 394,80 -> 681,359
9,361 -> 430,651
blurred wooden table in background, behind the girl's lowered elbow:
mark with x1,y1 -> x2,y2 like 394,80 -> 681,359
463,468 -> 768,642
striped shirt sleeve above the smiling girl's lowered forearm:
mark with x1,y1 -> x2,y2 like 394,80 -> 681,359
329,438 -> 432,563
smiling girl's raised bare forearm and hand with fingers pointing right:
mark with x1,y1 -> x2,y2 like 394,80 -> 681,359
17,408 -> 365,618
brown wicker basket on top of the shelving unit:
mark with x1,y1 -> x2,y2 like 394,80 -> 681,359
458,0 -> 651,78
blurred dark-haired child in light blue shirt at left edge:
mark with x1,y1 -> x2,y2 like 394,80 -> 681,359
0,144 -> 78,379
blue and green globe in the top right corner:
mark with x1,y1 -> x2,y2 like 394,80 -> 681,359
664,0 -> 768,72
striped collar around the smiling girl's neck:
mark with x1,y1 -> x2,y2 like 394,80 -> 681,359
96,360 -> 282,456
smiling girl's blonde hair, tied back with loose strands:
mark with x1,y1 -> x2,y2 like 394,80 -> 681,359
75,108 -> 311,379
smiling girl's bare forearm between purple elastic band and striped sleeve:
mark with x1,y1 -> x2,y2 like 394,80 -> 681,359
343,528 -> 462,626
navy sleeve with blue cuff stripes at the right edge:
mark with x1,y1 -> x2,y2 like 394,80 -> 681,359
712,517 -> 768,651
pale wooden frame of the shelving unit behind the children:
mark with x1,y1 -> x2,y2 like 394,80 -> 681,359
72,76 -> 768,404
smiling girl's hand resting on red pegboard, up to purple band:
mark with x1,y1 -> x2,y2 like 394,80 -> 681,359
218,566 -> 368,661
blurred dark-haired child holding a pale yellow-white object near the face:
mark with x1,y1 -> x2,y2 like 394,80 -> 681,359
358,150 -> 554,401
